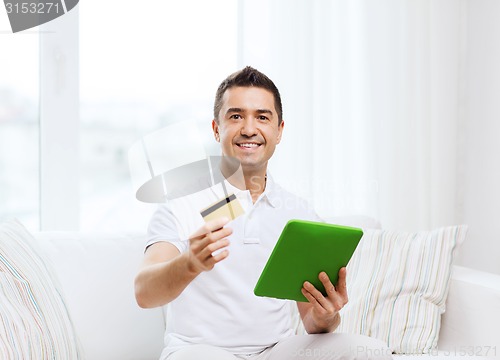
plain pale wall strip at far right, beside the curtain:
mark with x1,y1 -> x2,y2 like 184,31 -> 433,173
458,0 -> 500,273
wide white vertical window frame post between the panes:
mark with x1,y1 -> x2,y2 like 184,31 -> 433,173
39,6 -> 80,231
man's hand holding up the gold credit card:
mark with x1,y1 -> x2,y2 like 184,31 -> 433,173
188,217 -> 233,274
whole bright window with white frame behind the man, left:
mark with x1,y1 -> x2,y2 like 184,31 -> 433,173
0,0 -> 238,231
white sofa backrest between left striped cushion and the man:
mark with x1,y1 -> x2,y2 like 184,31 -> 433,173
36,232 -> 165,360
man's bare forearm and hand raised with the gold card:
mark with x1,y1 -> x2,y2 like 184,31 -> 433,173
135,218 -> 232,308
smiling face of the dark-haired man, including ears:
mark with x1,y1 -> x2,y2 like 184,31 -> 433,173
212,87 -> 284,174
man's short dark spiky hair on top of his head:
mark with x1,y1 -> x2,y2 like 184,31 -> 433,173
214,66 -> 283,125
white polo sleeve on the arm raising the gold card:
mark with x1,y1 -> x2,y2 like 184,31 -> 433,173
146,204 -> 189,253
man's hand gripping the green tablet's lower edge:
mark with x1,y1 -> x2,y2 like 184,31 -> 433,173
297,267 -> 348,334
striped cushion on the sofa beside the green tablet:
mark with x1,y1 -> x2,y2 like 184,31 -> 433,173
337,226 -> 467,354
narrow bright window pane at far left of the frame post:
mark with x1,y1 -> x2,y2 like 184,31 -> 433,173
0,11 -> 40,229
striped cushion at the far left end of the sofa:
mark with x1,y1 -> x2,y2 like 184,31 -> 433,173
0,220 -> 82,360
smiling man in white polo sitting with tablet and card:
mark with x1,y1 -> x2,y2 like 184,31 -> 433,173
135,67 -> 390,360
